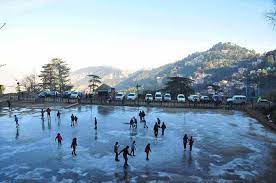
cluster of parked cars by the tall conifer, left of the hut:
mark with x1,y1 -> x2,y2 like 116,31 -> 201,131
38,91 -> 83,99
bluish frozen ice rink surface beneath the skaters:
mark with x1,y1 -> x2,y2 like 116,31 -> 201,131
0,105 -> 276,182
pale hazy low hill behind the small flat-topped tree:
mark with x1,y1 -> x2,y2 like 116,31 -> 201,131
71,66 -> 128,90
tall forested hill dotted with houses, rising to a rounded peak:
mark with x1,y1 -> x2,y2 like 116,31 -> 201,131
116,42 -> 259,89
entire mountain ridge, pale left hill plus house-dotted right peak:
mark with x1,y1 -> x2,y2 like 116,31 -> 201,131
71,42 -> 268,90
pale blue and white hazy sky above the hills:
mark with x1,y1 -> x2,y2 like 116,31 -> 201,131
0,0 -> 276,88
